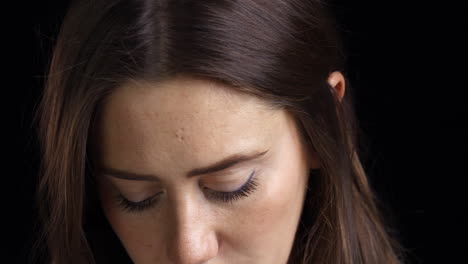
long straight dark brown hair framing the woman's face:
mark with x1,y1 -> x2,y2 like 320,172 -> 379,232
33,0 -> 402,264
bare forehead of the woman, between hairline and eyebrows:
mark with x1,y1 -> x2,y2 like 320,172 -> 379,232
93,78 -> 285,173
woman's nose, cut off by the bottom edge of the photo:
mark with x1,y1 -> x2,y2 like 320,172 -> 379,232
167,195 -> 219,264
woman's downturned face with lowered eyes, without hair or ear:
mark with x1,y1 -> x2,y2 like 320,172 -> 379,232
96,78 -> 318,264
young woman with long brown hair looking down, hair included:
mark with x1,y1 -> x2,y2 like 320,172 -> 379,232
37,0 -> 401,264
